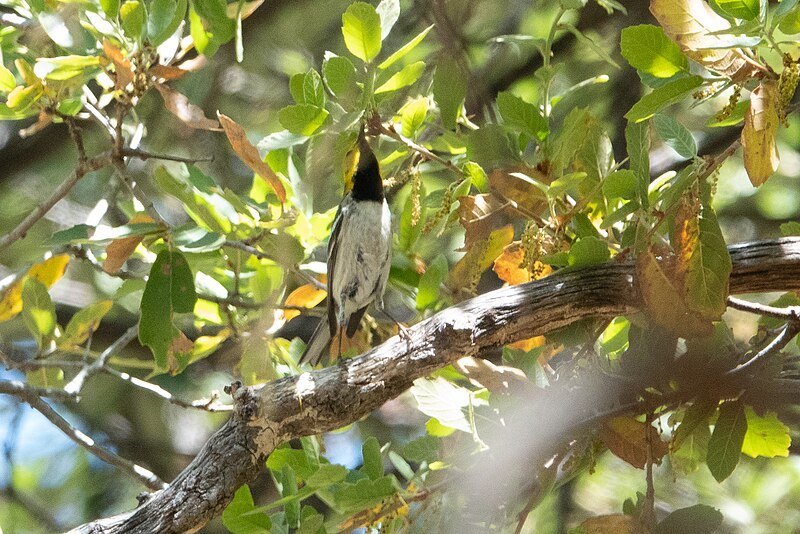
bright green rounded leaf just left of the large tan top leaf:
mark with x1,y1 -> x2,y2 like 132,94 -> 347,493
620,24 -> 689,78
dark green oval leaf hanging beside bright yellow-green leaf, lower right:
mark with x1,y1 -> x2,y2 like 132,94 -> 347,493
706,401 -> 747,482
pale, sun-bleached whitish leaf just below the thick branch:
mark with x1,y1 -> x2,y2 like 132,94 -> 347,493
411,377 -> 472,433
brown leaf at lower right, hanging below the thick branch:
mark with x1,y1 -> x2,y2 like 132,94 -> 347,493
599,416 -> 669,469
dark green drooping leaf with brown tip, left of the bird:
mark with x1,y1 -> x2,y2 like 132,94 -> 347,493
139,250 -> 197,371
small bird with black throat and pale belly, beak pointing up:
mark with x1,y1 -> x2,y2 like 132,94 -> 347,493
300,128 -> 392,366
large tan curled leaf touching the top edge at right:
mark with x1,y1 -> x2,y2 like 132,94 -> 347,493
650,0 -> 759,82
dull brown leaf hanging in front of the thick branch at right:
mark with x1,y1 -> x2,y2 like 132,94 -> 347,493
636,249 -> 713,337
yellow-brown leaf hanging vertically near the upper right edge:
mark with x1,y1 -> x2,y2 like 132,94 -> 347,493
742,80 -> 780,187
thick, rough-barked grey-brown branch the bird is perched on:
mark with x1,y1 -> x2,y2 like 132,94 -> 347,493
72,238 -> 800,534
